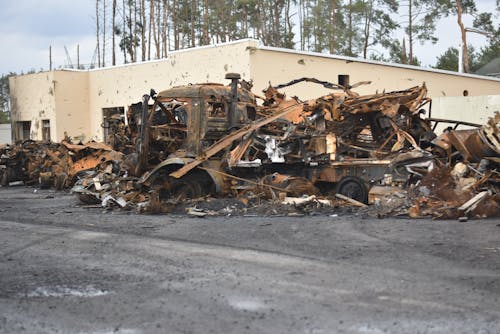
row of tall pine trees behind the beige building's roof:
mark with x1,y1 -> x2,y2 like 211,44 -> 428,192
101,0 -> 475,68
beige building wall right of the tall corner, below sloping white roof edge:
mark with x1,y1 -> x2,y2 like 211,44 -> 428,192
250,47 -> 500,99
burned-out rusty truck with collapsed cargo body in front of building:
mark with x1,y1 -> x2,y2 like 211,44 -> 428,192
128,73 -> 435,202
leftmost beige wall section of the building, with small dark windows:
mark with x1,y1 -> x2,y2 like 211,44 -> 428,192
9,72 -> 56,140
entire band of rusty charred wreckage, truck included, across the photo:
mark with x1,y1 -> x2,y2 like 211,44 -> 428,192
0,73 -> 500,219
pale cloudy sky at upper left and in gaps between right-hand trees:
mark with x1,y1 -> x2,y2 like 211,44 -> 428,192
0,0 -> 498,74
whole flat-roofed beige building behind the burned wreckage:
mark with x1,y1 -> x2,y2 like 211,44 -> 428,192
9,39 -> 500,141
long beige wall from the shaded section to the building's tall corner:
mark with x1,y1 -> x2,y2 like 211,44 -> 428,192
89,41 -> 255,140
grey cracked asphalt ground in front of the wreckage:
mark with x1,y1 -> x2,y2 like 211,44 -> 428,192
0,187 -> 500,334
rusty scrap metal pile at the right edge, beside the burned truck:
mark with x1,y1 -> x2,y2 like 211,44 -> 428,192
409,112 -> 500,218
